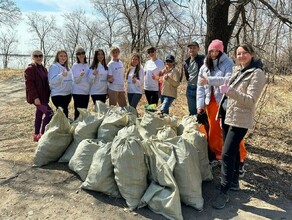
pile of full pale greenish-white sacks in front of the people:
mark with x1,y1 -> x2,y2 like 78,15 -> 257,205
34,102 -> 213,219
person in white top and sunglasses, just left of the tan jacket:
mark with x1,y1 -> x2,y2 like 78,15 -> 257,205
144,47 -> 164,105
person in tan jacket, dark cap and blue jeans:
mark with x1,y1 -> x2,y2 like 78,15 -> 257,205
159,55 -> 181,114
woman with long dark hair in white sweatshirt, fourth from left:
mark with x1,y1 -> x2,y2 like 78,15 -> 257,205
89,49 -> 108,105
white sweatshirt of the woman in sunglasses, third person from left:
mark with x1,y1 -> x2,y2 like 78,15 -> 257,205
71,63 -> 90,95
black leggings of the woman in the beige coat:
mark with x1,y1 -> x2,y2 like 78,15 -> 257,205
221,112 -> 248,193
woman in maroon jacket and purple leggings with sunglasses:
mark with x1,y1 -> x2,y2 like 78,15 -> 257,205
24,50 -> 53,141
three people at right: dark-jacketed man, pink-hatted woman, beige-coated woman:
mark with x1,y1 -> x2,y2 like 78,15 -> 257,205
184,39 -> 266,209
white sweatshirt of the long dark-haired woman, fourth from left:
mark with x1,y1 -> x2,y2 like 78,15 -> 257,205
89,63 -> 108,95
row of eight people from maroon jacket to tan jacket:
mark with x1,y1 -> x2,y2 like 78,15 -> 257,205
25,46 -> 180,141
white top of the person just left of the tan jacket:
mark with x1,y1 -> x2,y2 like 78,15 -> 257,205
144,59 -> 164,91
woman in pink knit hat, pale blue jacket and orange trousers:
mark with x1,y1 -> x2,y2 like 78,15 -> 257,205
197,39 -> 247,167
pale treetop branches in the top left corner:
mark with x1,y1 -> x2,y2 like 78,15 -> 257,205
0,0 -> 21,27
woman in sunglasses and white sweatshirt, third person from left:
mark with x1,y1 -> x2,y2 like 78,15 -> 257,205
71,46 -> 90,120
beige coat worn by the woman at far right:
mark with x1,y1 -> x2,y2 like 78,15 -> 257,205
219,64 -> 266,129
